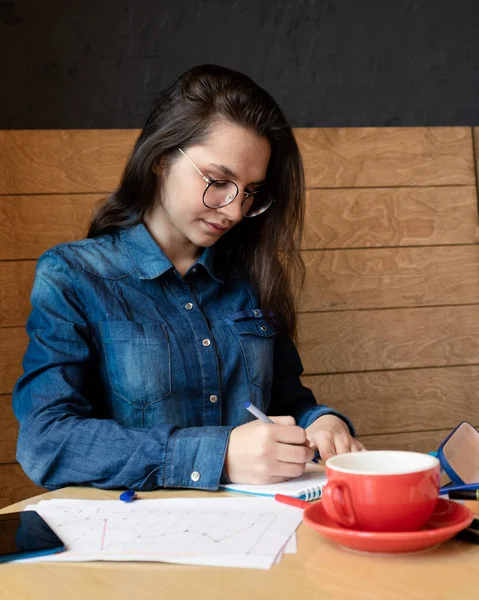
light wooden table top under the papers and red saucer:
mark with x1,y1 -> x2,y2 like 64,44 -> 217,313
0,488 -> 479,600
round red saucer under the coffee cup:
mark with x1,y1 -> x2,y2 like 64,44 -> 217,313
303,498 -> 474,552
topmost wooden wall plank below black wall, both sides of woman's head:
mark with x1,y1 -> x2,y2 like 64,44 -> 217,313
0,127 -> 474,194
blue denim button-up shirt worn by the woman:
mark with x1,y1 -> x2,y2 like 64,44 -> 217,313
13,224 -> 354,490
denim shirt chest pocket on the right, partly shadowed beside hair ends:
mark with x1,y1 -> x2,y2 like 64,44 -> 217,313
226,309 -> 278,388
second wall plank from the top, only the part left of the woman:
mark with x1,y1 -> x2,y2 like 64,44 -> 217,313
0,194 -> 99,260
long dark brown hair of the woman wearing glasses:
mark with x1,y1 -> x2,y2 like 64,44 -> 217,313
88,65 -> 305,337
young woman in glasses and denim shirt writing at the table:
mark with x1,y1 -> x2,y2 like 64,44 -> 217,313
13,65 -> 363,490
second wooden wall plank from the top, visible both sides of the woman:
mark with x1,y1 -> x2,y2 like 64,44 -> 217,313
0,186 -> 478,260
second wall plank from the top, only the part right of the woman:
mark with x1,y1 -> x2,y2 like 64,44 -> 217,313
302,186 -> 479,249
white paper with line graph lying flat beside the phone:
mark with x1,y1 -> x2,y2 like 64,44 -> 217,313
23,498 -> 302,569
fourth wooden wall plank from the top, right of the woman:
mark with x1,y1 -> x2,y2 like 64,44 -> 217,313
299,306 -> 479,375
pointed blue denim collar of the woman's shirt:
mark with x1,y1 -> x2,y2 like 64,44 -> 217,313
120,223 -> 224,283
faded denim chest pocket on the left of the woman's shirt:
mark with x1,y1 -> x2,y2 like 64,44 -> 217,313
100,321 -> 171,408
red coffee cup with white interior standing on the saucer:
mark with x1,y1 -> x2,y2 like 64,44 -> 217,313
321,450 -> 440,532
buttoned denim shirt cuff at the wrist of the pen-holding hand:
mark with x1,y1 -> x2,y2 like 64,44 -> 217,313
163,427 -> 233,490
